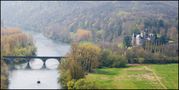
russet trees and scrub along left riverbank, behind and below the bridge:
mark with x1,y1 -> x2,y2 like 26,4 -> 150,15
1,28 -> 36,89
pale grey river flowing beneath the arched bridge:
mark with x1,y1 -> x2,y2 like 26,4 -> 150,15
9,32 -> 70,89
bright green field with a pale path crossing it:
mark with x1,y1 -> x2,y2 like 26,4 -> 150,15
86,64 -> 178,89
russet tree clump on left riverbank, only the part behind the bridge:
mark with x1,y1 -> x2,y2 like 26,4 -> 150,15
1,28 -> 35,56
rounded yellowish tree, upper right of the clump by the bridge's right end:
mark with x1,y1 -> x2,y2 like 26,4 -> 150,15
77,43 -> 101,72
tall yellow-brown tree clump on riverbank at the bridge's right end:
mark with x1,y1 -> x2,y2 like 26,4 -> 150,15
59,43 -> 101,87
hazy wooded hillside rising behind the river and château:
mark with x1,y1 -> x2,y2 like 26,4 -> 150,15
1,1 -> 178,46
